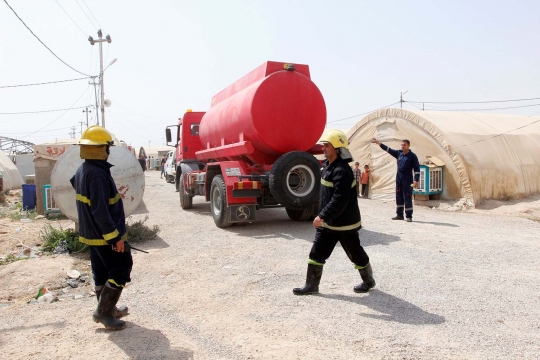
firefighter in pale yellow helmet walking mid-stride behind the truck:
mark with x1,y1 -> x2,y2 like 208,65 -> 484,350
293,130 -> 375,295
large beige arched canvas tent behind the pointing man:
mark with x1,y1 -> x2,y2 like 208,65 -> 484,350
347,109 -> 540,206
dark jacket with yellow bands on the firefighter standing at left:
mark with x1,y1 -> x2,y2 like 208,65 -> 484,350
70,160 -> 127,246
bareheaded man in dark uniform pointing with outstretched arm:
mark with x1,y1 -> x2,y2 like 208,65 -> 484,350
373,139 -> 420,222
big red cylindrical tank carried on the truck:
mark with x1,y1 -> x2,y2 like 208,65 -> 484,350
199,65 -> 326,162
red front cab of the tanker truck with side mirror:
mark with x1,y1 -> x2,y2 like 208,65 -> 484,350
165,109 -> 205,191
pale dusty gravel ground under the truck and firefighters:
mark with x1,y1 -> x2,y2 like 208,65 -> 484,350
0,172 -> 540,359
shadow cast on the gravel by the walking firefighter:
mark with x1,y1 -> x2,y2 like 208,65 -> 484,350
317,289 -> 445,325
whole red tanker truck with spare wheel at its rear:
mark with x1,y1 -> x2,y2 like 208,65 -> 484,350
166,61 -> 326,228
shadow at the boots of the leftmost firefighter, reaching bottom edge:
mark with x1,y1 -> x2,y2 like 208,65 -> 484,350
96,322 -> 193,360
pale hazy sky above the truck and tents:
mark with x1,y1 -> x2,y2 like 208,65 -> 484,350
0,0 -> 540,146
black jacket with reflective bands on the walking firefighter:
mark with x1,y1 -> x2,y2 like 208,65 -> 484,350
319,157 -> 362,231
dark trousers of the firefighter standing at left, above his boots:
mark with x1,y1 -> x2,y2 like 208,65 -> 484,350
90,245 -> 133,287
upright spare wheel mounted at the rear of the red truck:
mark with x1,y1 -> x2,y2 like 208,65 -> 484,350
270,151 -> 321,210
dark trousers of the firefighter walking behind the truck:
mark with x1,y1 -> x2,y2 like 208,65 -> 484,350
309,228 -> 369,268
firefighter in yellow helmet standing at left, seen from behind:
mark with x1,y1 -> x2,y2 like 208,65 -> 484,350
70,125 -> 133,330
